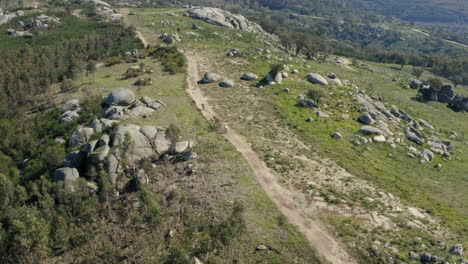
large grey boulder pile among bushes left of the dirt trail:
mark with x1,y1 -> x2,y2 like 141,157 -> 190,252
54,88 -> 196,192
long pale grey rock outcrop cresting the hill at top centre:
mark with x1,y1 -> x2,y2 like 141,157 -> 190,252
188,7 -> 263,32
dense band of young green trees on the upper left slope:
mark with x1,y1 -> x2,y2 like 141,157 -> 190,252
0,24 -> 142,117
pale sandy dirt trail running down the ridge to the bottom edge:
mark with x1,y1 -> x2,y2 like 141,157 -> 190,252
185,52 -> 356,264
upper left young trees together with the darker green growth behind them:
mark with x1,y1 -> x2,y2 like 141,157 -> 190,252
0,11 -> 142,116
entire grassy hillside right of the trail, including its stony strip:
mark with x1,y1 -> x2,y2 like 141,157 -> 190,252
124,9 -> 468,263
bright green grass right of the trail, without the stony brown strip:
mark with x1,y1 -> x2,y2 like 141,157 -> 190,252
122,6 -> 468,258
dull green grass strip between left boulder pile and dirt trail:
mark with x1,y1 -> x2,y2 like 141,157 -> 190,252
55,47 -> 321,263
